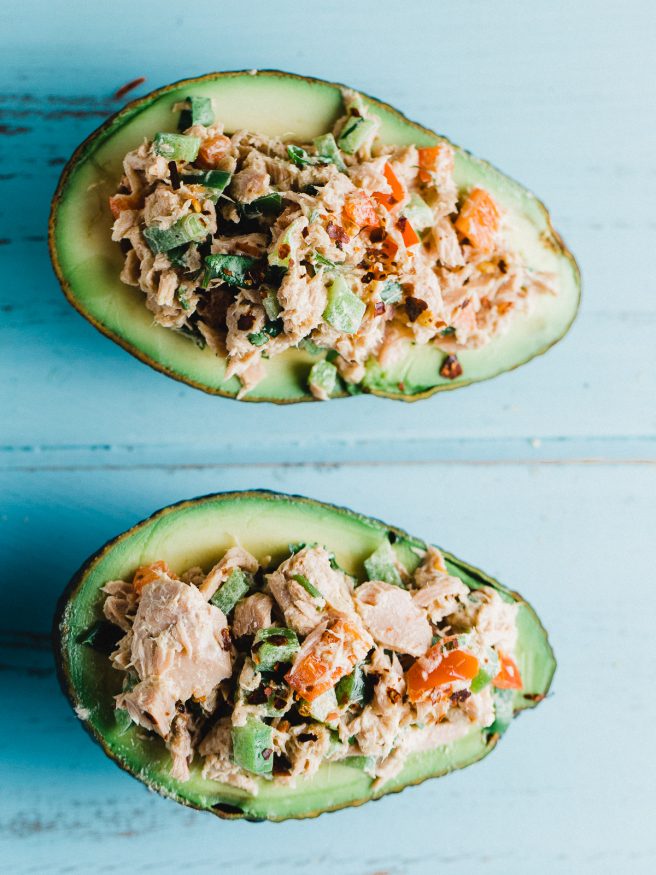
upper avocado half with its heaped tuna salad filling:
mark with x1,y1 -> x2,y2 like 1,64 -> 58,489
50,71 -> 580,402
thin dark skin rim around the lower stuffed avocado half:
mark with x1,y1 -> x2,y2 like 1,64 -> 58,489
52,490 -> 556,823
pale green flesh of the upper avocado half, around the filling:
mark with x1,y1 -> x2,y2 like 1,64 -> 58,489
50,71 -> 580,402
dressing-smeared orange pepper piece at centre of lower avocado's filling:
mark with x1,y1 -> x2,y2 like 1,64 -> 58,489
285,616 -> 371,702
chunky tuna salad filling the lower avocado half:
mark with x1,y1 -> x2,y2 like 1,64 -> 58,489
103,542 -> 522,795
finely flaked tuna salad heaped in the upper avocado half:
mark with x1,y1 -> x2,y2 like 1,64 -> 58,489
109,90 -> 554,399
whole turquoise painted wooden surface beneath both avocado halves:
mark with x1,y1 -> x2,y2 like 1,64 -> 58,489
0,0 -> 656,875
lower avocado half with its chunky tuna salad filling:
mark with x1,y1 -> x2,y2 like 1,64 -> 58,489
54,491 -> 555,820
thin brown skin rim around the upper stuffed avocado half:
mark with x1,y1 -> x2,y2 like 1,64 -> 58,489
48,70 -> 581,404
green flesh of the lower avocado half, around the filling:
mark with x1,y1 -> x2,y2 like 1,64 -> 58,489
54,491 -> 556,820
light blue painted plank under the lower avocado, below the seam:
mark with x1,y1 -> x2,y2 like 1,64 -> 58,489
0,464 -> 656,875
